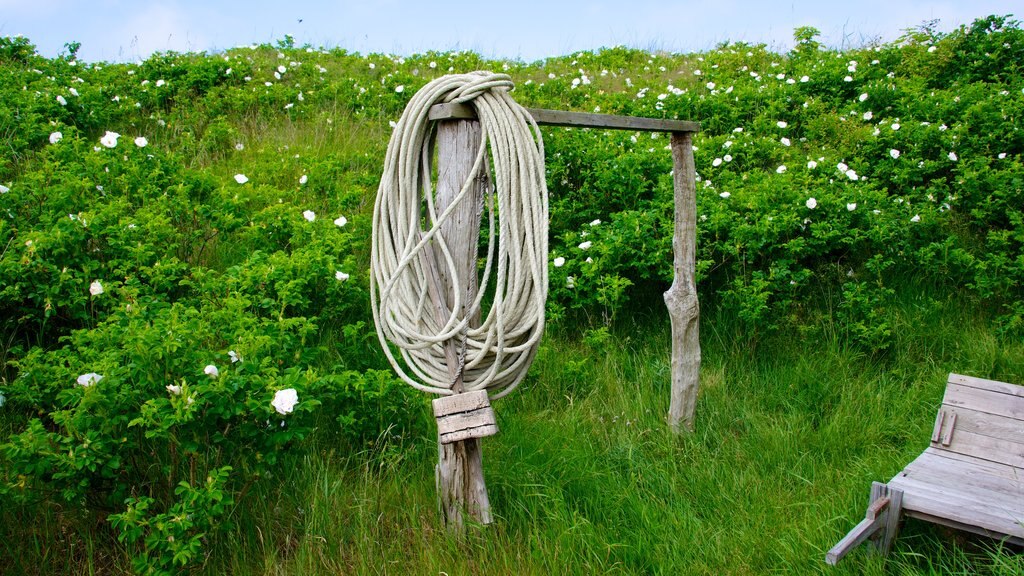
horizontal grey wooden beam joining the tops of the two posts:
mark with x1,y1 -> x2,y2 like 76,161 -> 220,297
428,104 -> 700,132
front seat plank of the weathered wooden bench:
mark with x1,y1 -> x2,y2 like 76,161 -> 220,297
889,476 -> 1024,537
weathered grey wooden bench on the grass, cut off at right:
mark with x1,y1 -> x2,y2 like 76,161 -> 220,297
825,374 -> 1024,565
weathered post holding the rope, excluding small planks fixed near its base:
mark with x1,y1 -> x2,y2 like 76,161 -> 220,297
435,120 -> 492,530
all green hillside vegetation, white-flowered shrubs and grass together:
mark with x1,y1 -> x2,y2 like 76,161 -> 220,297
0,16 -> 1024,574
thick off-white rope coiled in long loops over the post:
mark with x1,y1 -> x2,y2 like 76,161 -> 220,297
370,72 -> 548,399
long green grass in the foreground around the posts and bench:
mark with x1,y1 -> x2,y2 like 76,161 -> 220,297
201,289 -> 1024,575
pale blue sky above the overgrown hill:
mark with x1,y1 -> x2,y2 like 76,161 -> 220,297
0,0 -> 1024,61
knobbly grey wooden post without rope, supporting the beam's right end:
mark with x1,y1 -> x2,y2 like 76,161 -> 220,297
665,132 -> 700,433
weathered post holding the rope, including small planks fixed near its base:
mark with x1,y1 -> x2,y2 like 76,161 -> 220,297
433,120 -> 498,529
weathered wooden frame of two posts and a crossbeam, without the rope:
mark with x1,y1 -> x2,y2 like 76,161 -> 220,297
428,104 -> 700,528
